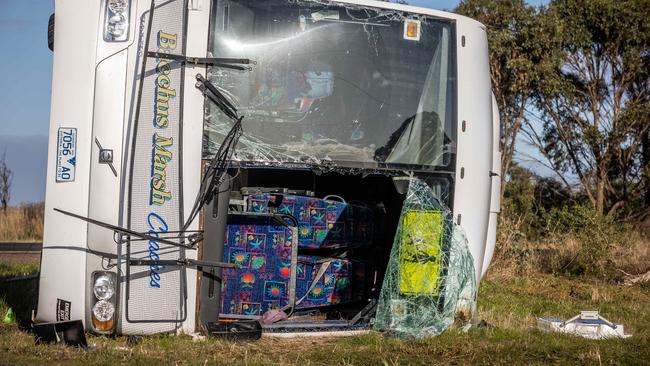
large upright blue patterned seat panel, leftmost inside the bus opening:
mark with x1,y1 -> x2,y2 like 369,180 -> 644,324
221,215 -> 297,318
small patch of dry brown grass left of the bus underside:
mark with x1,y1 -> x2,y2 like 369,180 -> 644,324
0,203 -> 44,242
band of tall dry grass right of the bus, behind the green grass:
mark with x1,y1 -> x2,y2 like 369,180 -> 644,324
492,210 -> 650,282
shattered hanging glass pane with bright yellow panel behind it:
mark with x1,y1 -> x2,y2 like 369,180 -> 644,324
374,178 -> 476,338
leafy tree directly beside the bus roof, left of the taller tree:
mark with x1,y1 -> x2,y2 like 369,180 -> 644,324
455,0 -> 555,202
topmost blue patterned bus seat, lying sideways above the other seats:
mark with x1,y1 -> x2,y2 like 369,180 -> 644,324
248,193 -> 374,249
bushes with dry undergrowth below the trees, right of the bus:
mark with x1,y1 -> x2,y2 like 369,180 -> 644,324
494,166 -> 650,280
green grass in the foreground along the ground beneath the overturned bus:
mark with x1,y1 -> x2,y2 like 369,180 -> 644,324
0,268 -> 650,365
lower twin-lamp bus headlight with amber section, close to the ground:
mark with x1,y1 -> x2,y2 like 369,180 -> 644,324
91,272 -> 117,333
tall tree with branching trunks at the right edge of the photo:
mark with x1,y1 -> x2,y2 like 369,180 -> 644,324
529,0 -> 650,214
